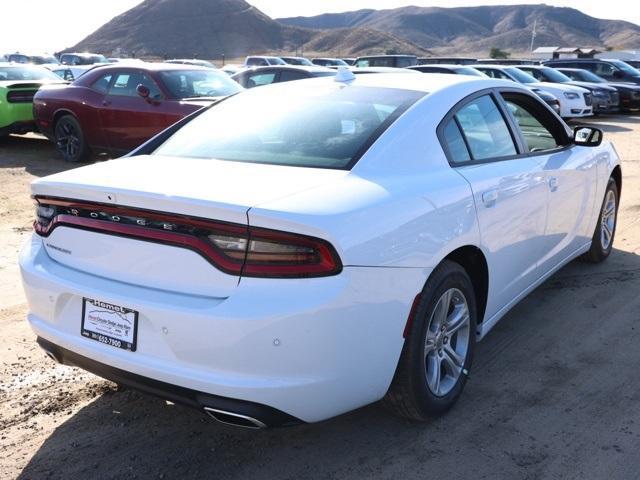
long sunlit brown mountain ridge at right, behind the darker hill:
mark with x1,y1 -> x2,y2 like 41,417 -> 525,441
278,5 -> 640,52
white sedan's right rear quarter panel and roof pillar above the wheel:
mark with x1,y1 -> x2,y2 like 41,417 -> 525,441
249,80 -> 484,268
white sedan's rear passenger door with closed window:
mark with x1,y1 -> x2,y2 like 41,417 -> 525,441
439,92 -> 547,318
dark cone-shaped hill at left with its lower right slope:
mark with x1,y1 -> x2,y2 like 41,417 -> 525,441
69,0 -> 427,59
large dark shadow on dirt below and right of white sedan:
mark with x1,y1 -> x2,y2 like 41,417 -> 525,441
18,250 -> 640,480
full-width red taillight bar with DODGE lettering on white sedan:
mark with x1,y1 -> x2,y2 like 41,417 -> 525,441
34,197 -> 342,278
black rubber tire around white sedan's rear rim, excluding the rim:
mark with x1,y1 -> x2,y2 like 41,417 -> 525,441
383,260 -> 477,421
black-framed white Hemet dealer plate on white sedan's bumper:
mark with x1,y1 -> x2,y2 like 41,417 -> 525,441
80,298 -> 138,352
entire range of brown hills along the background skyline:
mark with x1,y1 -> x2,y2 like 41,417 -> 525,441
69,0 -> 640,59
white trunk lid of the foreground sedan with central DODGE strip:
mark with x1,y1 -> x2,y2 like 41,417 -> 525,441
32,156 -> 347,297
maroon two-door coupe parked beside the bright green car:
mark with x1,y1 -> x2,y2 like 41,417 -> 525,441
33,63 -> 243,162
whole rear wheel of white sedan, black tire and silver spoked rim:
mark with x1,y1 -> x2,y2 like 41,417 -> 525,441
384,260 -> 476,421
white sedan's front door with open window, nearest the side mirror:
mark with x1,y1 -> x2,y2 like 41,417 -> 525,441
501,91 -> 597,275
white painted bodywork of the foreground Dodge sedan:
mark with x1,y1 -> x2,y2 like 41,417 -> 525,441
20,74 -> 619,422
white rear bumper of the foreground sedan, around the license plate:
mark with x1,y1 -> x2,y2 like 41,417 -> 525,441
20,235 -> 430,423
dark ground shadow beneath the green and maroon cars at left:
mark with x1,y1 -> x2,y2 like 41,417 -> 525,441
0,134 -> 99,177
